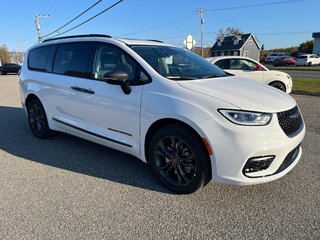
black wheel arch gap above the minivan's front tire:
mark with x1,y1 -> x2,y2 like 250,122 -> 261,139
144,118 -> 212,179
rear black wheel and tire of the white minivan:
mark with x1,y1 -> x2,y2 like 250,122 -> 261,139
27,99 -> 52,138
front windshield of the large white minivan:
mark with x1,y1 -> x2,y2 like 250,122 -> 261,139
131,45 -> 228,80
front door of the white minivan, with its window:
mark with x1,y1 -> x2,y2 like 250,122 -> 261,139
83,43 -> 150,155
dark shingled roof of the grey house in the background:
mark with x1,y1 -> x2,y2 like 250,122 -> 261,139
210,33 -> 260,51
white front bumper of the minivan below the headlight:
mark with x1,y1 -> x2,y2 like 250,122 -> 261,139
203,109 -> 305,185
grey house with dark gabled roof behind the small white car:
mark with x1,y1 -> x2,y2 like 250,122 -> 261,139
210,33 -> 261,61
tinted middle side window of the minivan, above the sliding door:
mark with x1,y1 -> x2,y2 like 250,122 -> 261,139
53,42 -> 92,78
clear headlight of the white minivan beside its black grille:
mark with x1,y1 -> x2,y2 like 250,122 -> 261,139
218,109 -> 272,126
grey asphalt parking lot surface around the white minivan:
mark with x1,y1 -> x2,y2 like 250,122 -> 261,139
0,75 -> 320,239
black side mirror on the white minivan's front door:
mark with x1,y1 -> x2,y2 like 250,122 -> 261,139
103,71 -> 131,94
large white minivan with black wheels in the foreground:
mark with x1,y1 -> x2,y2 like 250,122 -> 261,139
19,35 -> 305,193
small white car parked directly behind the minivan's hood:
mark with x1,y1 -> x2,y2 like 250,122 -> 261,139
206,56 -> 292,93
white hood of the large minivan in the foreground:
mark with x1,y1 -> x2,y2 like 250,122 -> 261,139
179,76 -> 296,113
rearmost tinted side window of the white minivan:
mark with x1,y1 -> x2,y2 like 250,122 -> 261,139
28,45 -> 55,72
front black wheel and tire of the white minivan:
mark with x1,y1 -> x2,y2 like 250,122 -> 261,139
149,125 -> 211,194
